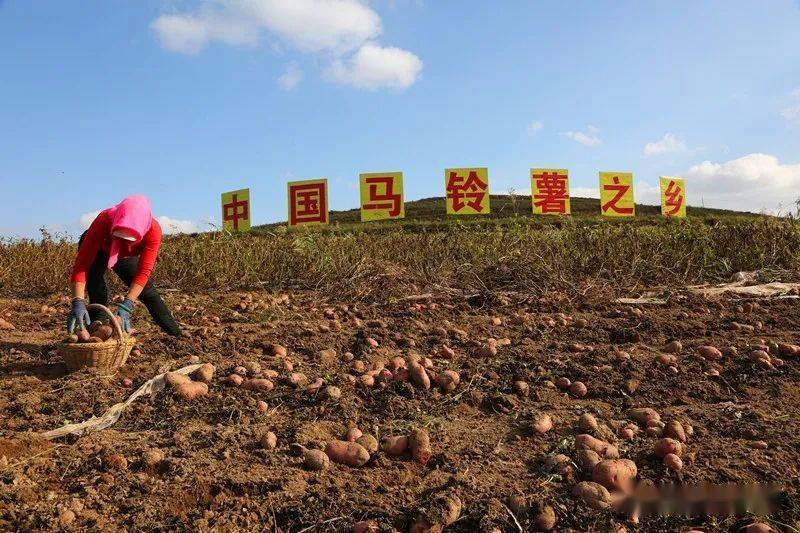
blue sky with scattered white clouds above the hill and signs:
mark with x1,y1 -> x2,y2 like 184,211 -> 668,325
0,0 -> 800,236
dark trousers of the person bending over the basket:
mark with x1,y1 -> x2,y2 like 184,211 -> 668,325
78,233 -> 181,335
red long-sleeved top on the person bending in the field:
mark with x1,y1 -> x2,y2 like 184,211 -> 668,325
72,209 -> 161,286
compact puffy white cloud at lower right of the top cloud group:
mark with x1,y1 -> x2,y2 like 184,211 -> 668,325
325,43 -> 422,90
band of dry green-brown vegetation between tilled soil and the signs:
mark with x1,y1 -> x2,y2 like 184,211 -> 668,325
0,197 -> 800,299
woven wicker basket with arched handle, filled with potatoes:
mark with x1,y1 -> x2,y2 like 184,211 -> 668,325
58,304 -> 136,370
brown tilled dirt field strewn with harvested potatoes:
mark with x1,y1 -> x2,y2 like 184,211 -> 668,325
0,284 -> 800,532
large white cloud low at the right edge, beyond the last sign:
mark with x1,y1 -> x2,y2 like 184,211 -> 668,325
685,153 -> 800,213
